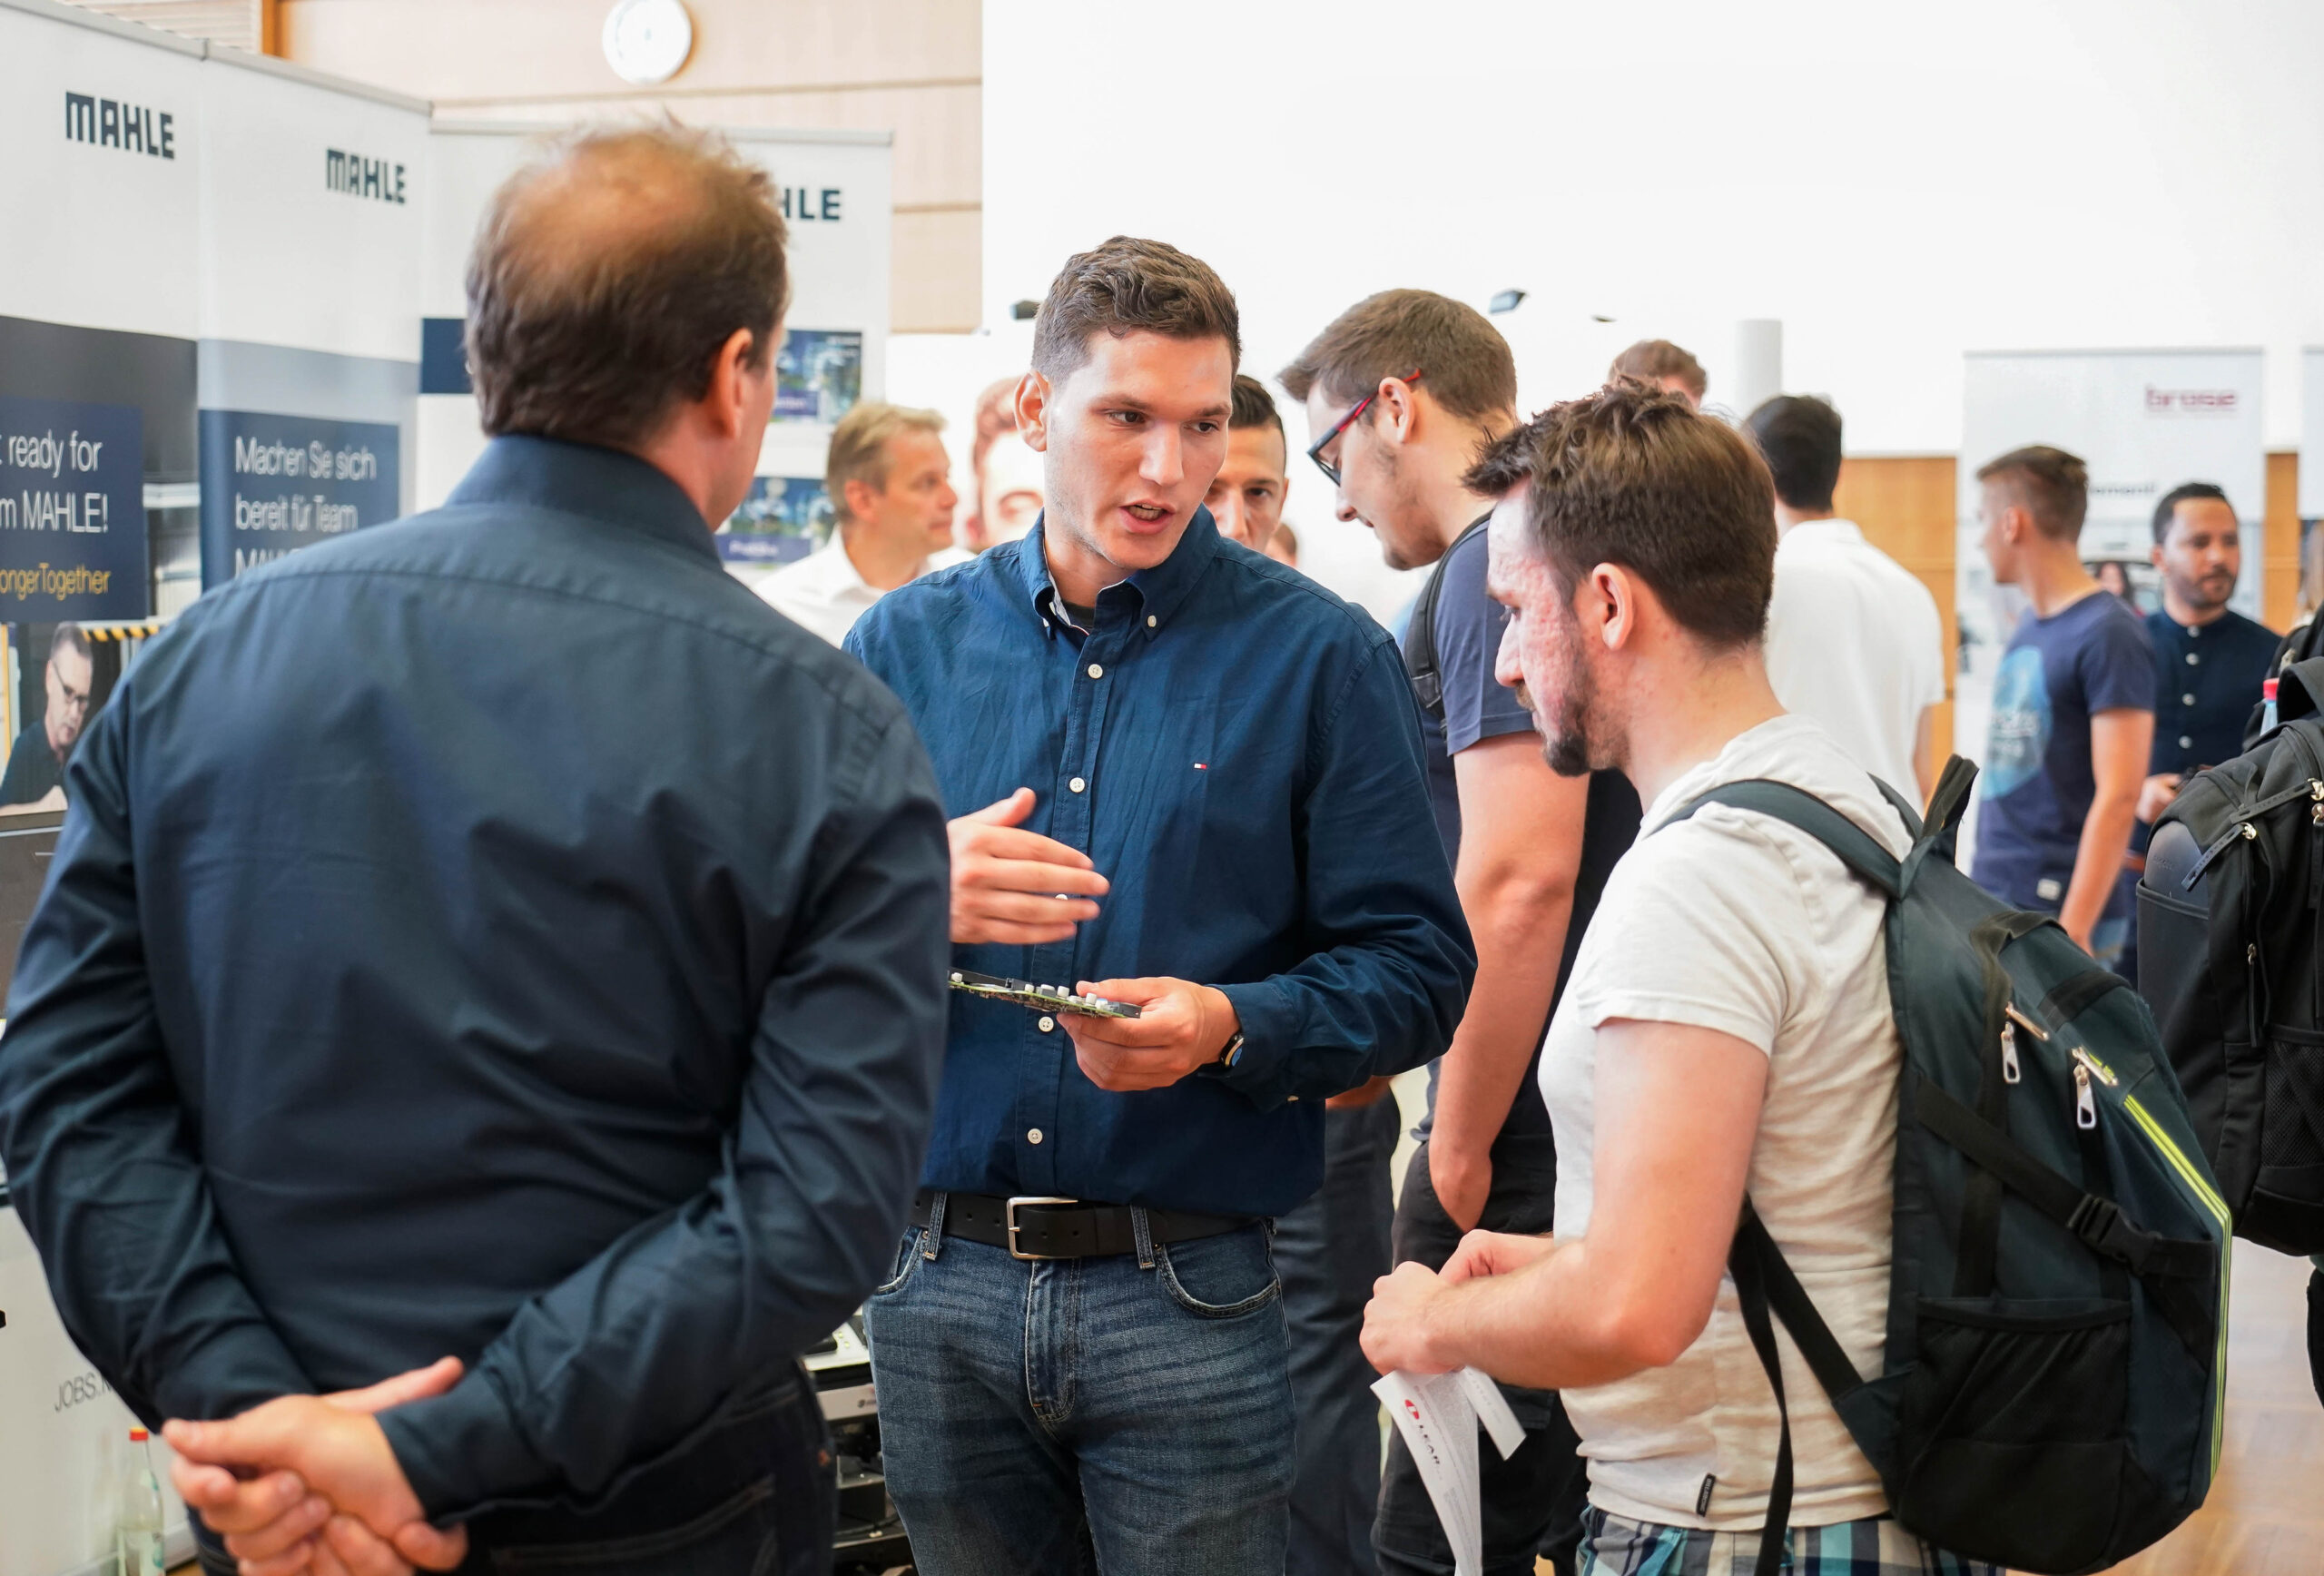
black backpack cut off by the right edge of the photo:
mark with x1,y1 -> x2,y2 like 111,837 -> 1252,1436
2138,658 -> 2324,1256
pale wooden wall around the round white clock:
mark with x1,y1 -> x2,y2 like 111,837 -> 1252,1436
274,0 -> 983,332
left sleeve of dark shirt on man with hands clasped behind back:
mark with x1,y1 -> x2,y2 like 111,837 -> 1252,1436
0,685 -> 314,1427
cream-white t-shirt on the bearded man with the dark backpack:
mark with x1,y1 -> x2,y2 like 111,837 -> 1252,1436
1541,716 -> 1908,1532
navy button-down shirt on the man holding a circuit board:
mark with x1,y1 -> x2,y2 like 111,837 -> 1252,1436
846,509 -> 1476,1216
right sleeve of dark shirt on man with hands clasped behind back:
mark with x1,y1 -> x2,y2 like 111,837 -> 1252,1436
381,714 -> 950,1518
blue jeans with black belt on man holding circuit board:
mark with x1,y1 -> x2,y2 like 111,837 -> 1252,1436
864,1216 -> 1292,1576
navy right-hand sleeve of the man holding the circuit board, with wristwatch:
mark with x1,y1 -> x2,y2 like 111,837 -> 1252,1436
1206,635 -> 1476,1108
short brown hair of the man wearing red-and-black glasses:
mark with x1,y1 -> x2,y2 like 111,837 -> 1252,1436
1275,291 -> 1518,423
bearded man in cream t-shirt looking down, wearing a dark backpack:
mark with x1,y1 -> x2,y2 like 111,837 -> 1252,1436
1364,389 -> 1996,1576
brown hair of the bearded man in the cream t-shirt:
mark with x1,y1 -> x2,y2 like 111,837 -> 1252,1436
1462,381 -> 1776,651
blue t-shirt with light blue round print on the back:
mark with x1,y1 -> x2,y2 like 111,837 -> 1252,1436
1971,590 -> 2154,918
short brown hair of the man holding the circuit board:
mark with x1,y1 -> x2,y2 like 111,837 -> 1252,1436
1032,235 -> 1244,383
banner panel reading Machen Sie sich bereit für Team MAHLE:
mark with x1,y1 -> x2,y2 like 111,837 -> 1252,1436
195,51 -> 428,611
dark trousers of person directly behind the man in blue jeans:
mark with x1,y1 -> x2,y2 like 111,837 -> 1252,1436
1275,1095 -> 1402,1576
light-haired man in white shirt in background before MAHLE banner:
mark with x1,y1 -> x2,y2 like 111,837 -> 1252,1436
758,399 -> 967,646
